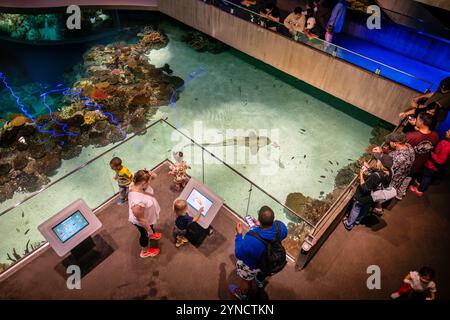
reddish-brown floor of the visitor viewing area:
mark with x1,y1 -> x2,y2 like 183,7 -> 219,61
0,165 -> 450,299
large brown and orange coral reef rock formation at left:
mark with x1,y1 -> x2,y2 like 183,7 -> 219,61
0,27 -> 179,202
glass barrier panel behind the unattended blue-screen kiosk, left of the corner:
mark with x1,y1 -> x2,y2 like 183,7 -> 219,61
0,122 -> 169,272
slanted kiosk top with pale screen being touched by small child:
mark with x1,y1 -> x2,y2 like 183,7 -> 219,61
180,178 -> 223,229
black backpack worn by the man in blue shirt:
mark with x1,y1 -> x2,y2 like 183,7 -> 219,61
247,222 -> 287,276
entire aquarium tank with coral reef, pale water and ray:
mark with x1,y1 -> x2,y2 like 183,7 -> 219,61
0,10 -> 392,270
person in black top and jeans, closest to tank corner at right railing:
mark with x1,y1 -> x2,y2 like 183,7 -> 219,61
343,155 -> 393,231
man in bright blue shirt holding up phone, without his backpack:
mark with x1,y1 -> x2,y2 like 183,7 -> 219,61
229,206 -> 287,300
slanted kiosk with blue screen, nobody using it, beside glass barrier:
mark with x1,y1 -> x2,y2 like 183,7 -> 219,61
38,199 -> 102,257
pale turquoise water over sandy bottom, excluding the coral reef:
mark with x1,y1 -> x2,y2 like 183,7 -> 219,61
0,16 -> 380,264
